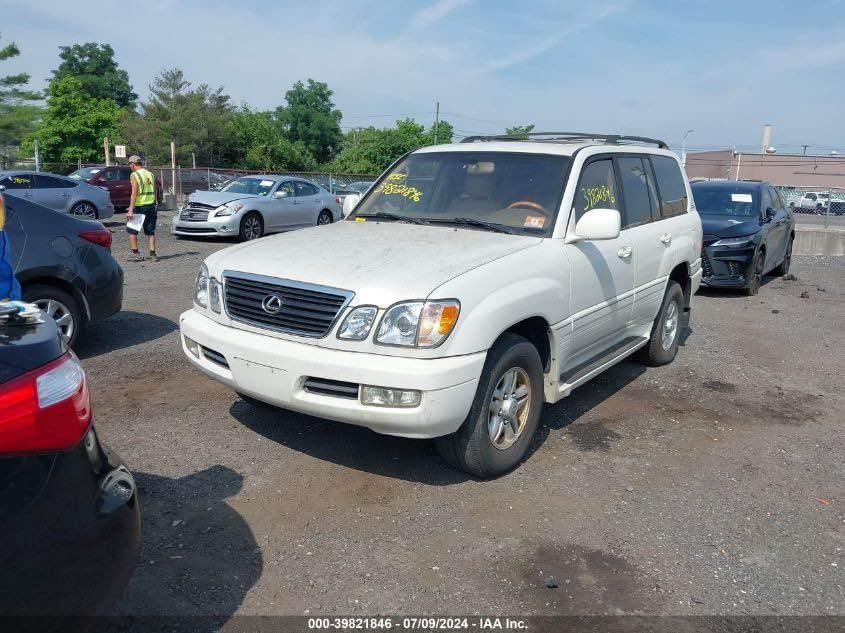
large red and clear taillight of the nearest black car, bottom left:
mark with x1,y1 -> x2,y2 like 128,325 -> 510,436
0,352 -> 91,454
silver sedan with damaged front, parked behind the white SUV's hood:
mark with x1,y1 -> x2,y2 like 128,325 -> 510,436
172,174 -> 341,241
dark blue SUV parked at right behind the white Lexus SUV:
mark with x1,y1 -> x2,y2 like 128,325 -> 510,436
692,180 -> 795,295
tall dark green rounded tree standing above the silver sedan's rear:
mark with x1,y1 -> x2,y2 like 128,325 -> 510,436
276,79 -> 343,163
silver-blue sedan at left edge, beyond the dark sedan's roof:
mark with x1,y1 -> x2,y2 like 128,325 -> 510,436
0,171 -> 114,220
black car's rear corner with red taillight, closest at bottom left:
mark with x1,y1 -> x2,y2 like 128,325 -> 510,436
0,319 -> 140,616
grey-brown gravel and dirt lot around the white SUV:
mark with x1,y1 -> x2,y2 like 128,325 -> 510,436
79,212 -> 845,618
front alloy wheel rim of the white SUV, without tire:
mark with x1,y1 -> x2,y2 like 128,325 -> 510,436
487,367 -> 531,451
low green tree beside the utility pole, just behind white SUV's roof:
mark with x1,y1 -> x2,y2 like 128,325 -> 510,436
331,119 -> 453,174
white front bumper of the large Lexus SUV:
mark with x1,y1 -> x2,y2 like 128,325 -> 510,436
179,310 -> 487,438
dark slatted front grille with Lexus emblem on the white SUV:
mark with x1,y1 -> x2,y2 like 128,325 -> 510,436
223,271 -> 354,338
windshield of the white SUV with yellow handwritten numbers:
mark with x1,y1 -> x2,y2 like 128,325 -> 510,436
350,152 -> 570,235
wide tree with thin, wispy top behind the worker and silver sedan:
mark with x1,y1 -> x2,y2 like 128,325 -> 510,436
122,68 -> 234,165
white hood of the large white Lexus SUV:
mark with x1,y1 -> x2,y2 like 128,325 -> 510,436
206,222 -> 543,308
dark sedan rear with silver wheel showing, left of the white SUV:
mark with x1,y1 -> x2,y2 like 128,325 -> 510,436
3,196 -> 123,346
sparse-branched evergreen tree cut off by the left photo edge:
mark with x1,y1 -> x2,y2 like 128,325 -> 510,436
0,42 -> 43,169
